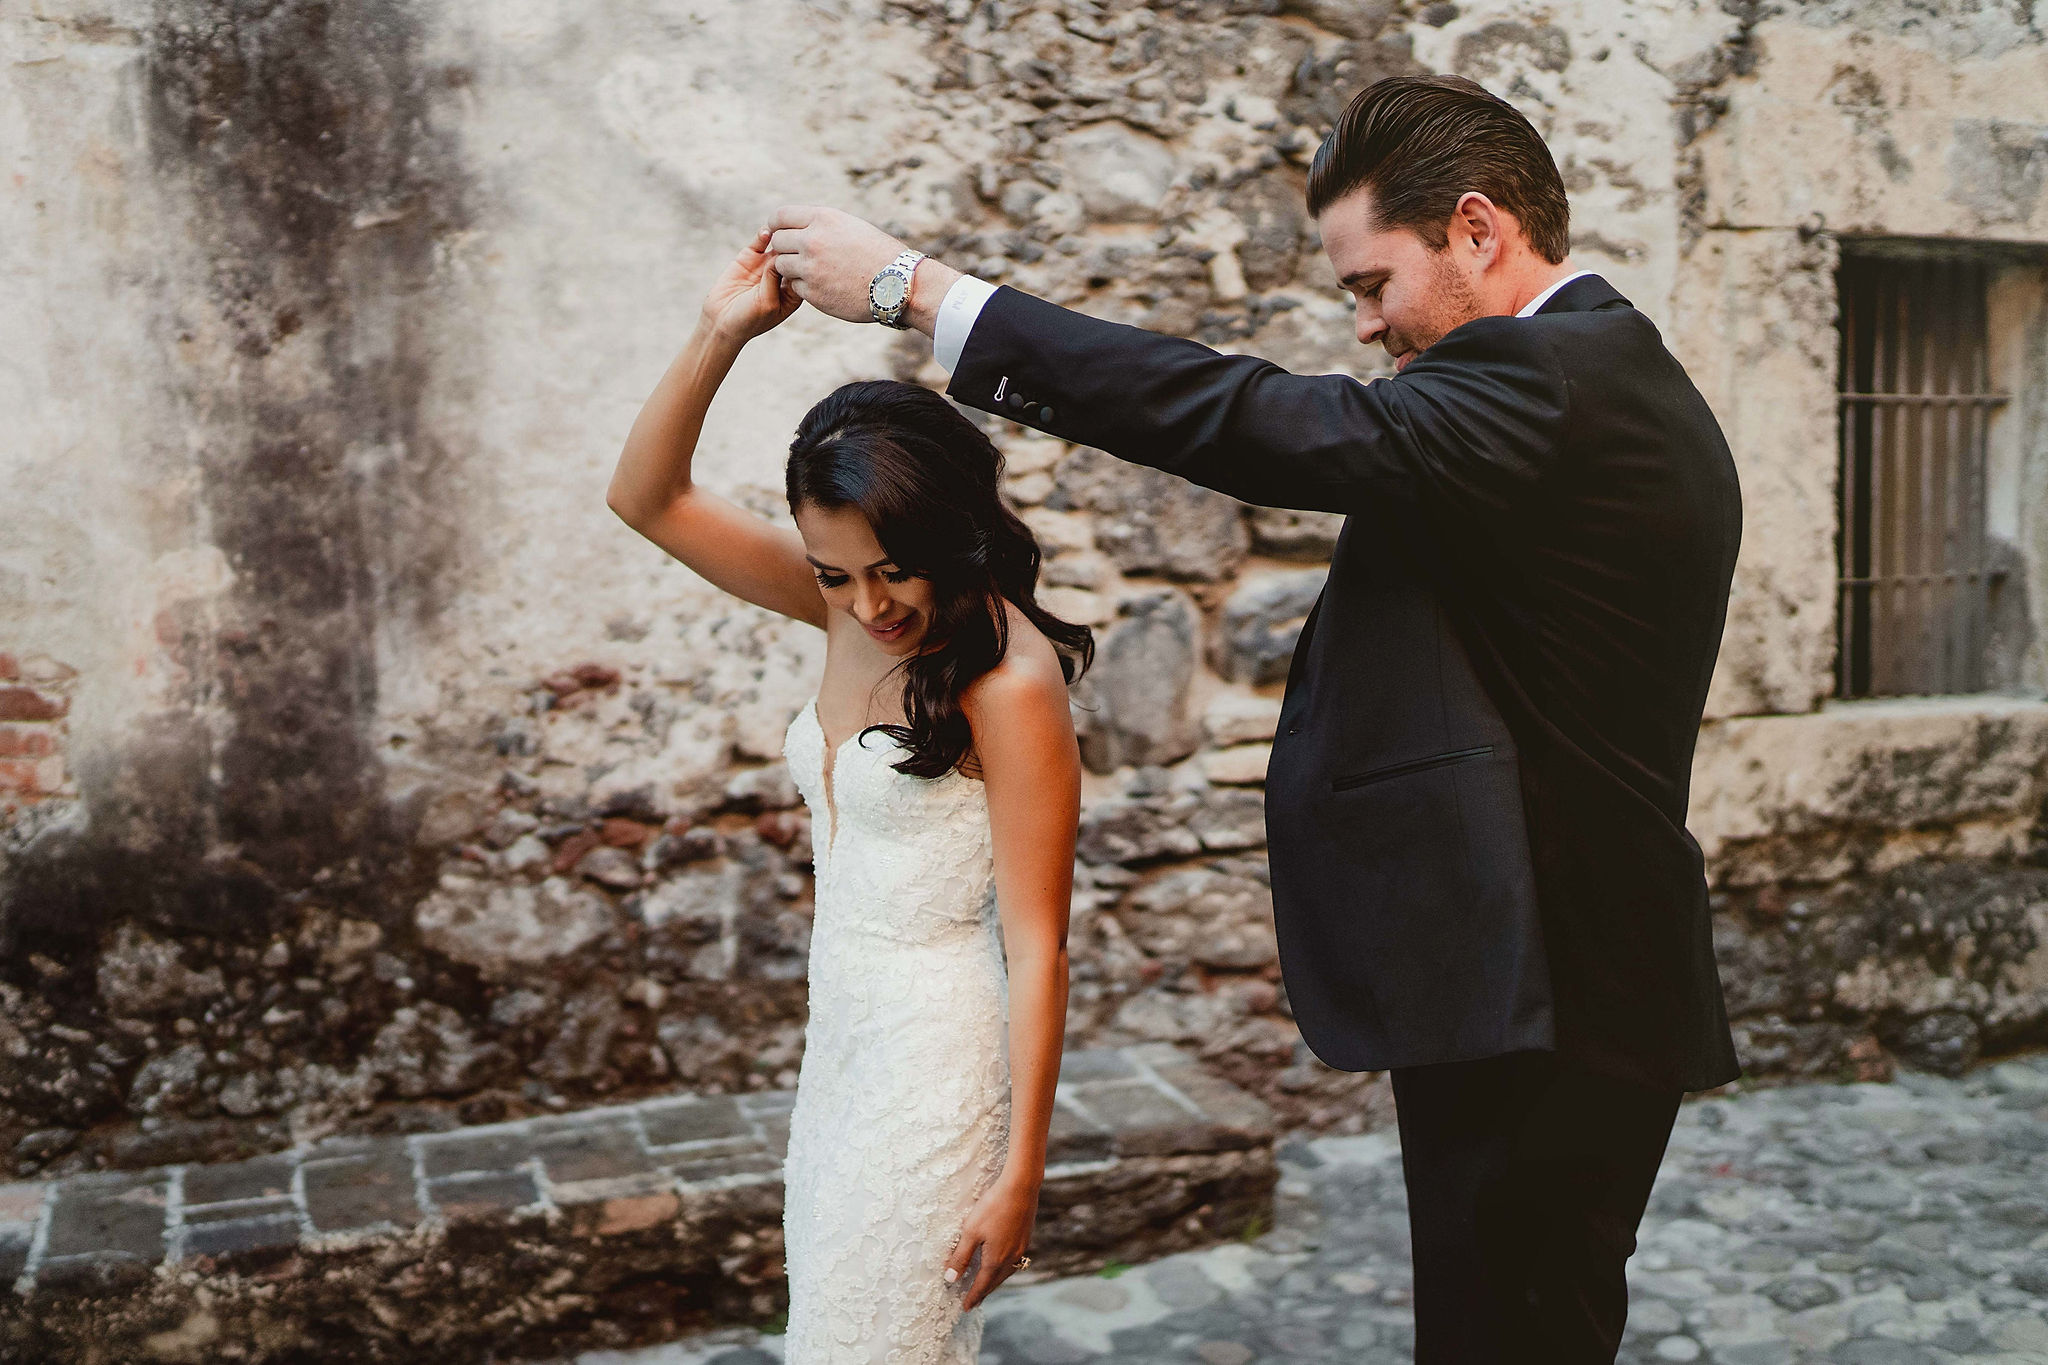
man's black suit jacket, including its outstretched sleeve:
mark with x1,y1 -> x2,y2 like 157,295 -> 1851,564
950,276 -> 1741,1089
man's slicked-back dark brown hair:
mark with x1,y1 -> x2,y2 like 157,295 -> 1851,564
1309,76 -> 1571,264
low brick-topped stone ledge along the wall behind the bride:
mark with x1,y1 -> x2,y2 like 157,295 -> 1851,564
0,1044 -> 1276,1365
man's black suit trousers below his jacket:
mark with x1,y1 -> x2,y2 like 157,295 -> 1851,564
1393,1052 -> 1681,1365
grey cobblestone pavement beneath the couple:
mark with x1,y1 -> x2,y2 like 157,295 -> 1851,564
575,1056 -> 2048,1365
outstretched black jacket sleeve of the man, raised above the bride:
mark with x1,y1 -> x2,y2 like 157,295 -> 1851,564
948,289 -> 1571,514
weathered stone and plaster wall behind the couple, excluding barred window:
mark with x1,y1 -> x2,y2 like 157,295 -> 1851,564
12,0 -> 2048,1175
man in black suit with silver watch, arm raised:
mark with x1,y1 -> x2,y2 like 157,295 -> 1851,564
772,78 -> 1741,1365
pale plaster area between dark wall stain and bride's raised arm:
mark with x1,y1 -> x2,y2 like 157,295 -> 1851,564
383,2 -> 958,835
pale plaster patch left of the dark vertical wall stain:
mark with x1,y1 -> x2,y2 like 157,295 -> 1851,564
0,16 -> 181,888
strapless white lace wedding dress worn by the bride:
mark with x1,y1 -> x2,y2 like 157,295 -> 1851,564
782,698 -> 1010,1365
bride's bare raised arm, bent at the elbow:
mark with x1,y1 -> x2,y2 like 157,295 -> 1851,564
604,229 -> 825,628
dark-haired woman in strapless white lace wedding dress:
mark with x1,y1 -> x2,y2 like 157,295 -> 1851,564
608,231 -> 1092,1365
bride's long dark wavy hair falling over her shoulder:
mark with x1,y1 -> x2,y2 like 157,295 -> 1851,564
784,379 -> 1096,778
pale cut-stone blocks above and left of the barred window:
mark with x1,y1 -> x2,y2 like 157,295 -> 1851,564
1675,4 -> 2048,716
